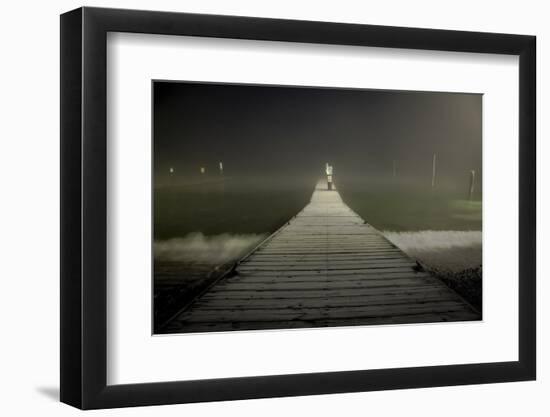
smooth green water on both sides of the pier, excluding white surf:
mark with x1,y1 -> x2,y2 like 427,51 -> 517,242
154,177 -> 482,240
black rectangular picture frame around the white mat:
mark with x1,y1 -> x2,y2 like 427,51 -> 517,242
60,7 -> 536,409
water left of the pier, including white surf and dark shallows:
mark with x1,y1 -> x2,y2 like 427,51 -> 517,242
153,175 -> 315,326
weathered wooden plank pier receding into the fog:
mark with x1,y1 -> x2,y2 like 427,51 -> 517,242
165,181 -> 480,333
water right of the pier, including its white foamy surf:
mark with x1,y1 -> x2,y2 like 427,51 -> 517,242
339,178 -> 482,272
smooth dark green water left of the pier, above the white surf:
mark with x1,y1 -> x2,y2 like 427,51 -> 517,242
154,176 -> 316,240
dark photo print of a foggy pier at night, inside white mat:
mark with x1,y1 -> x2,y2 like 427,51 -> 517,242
152,80 -> 483,334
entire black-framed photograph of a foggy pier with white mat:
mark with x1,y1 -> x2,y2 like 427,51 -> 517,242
60,7 -> 536,409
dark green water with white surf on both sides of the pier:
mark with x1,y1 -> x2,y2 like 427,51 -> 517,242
154,176 -> 482,325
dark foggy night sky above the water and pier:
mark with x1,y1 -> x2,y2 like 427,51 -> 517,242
154,81 -> 482,183
